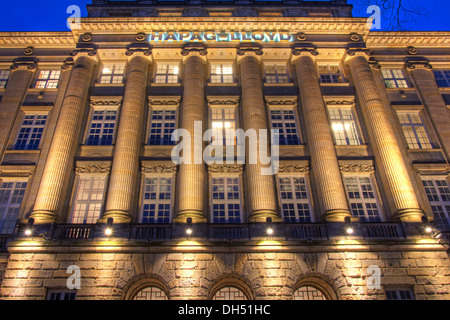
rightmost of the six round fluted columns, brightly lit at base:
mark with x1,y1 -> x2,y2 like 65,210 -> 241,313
348,49 -> 423,222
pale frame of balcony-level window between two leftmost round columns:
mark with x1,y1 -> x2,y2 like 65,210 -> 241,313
68,173 -> 109,224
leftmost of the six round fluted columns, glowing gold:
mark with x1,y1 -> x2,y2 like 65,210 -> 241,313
31,49 -> 97,223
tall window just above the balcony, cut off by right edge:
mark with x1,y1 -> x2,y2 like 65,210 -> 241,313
422,177 -> 450,231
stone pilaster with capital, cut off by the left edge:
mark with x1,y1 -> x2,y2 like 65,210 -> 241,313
0,62 -> 36,163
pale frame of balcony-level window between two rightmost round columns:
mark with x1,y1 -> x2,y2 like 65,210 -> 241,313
342,173 -> 385,223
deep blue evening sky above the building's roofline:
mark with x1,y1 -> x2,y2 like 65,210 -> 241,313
0,0 -> 450,31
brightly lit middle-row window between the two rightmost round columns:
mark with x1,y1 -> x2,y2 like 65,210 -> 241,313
328,107 -> 361,146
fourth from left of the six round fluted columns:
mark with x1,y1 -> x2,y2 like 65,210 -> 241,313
238,49 -> 280,222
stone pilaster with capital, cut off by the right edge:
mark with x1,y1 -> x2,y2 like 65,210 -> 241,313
406,61 -> 450,159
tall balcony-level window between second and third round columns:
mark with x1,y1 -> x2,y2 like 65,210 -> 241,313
142,177 -> 173,223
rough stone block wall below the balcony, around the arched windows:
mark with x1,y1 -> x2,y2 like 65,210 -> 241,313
0,251 -> 450,300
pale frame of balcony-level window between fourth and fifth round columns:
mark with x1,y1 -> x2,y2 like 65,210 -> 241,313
276,173 -> 316,223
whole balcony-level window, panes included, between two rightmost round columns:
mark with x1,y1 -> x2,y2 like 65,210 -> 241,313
344,177 -> 381,222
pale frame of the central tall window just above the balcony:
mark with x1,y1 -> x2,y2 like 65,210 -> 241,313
209,173 -> 244,224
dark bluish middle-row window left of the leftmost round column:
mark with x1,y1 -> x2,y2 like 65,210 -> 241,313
13,114 -> 47,150
